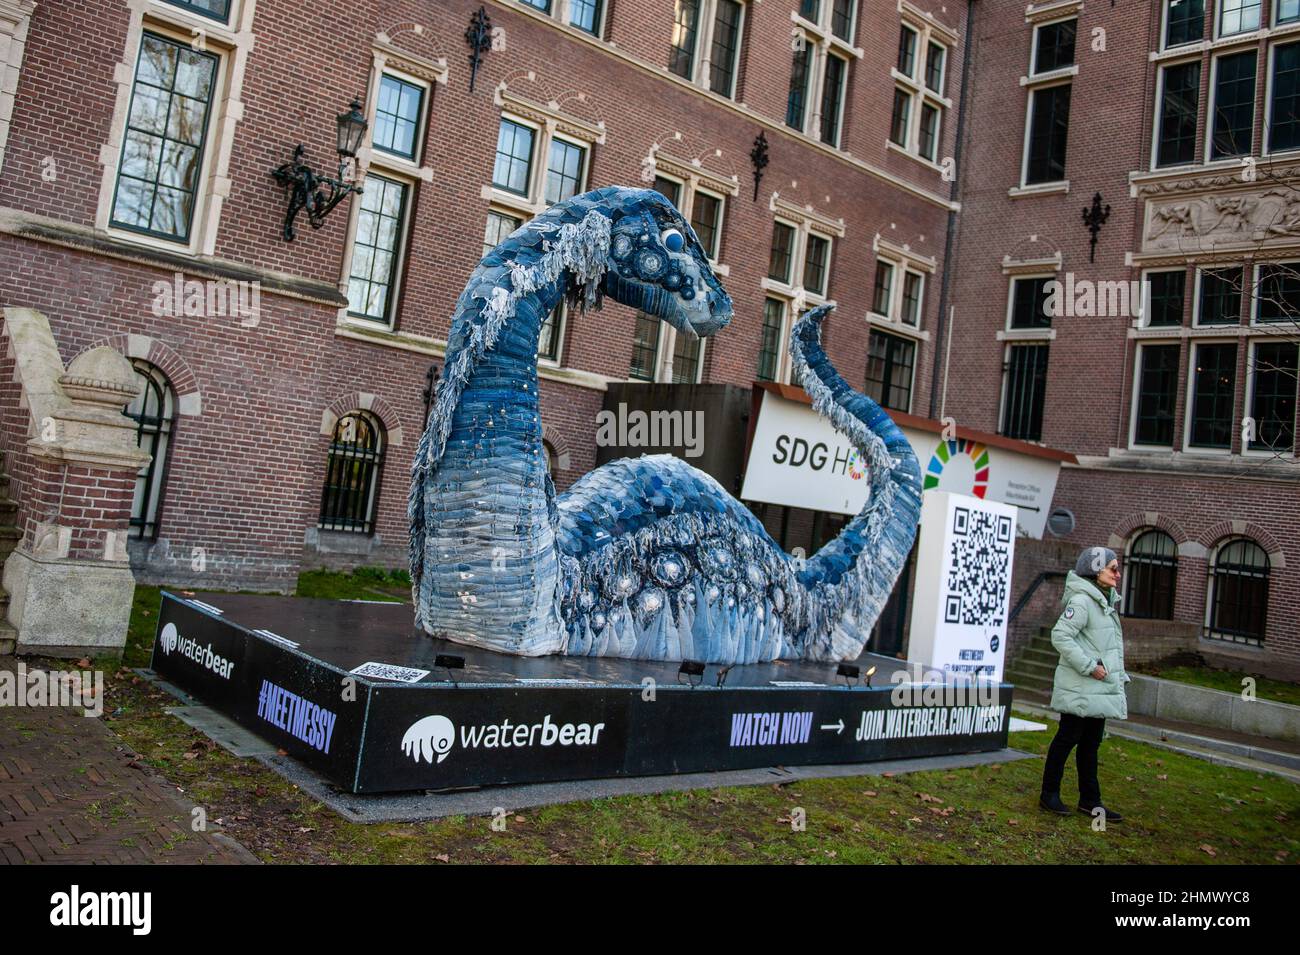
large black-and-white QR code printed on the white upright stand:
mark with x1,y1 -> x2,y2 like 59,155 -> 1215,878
944,507 -> 1013,626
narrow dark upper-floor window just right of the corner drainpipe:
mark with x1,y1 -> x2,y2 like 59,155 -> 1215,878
1021,17 -> 1079,186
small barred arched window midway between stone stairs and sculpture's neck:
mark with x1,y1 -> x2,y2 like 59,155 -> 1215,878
320,411 -> 384,534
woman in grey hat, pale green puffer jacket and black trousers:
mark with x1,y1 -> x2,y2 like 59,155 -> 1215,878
1039,547 -> 1130,822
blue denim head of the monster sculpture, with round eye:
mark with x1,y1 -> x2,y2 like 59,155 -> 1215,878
601,187 -> 732,338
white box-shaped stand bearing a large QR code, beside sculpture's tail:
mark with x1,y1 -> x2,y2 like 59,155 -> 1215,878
907,491 -> 1017,683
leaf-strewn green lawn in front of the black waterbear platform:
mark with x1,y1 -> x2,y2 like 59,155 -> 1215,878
107,574 -> 1300,864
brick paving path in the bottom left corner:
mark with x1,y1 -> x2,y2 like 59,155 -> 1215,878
0,656 -> 256,864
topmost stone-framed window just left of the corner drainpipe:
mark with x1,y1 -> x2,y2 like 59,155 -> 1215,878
889,15 -> 948,162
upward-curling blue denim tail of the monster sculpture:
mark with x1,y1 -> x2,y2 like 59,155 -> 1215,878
790,305 -> 920,660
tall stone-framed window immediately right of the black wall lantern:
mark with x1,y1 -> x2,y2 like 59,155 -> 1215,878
343,54 -> 446,327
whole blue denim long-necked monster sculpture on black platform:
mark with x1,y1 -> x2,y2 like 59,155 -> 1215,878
410,187 -> 920,664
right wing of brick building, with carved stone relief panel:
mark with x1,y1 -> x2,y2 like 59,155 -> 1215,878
945,0 -> 1300,677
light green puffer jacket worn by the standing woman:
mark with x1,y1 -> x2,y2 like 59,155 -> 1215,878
1052,570 -> 1130,720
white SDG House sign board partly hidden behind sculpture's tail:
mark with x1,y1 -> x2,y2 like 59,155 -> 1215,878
741,391 -> 1061,539
